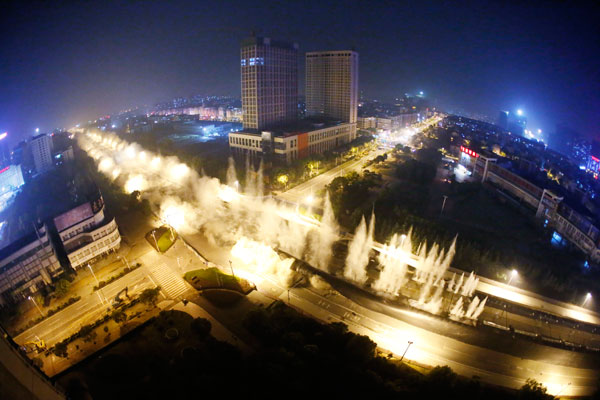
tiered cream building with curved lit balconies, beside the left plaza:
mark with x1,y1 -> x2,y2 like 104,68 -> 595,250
54,196 -> 121,269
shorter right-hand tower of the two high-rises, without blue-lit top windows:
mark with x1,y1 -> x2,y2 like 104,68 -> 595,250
306,50 -> 358,130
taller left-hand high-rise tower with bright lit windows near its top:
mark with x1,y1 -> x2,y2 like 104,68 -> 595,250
240,36 -> 298,130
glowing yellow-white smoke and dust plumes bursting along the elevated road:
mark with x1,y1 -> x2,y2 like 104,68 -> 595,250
78,132 -> 485,324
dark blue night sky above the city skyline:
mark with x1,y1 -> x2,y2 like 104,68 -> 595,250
0,0 -> 600,144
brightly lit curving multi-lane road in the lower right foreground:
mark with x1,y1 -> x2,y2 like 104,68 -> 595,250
288,289 -> 599,396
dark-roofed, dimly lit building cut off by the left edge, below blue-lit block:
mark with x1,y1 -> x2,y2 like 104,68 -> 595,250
0,225 -> 63,304
